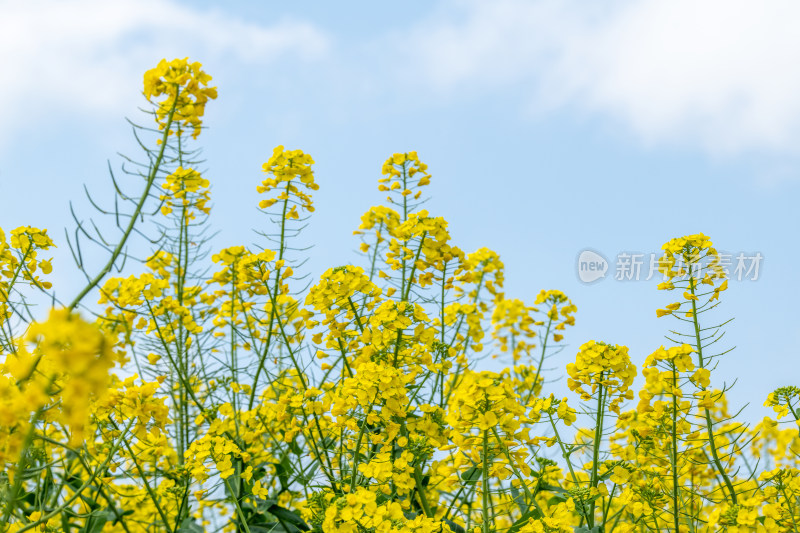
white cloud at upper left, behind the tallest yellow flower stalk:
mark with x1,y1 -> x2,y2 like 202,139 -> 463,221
0,0 -> 329,144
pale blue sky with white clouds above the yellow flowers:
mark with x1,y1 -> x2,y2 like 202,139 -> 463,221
0,0 -> 800,420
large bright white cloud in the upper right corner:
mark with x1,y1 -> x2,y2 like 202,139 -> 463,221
403,0 -> 800,153
